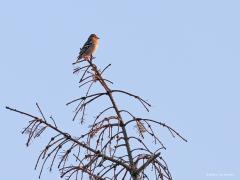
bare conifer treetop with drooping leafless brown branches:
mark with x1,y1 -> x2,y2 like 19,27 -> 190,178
6,55 -> 187,180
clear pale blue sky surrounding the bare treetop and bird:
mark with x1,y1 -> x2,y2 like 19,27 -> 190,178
0,0 -> 240,180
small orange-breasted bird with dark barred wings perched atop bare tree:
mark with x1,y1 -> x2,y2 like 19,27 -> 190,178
77,34 -> 99,61
